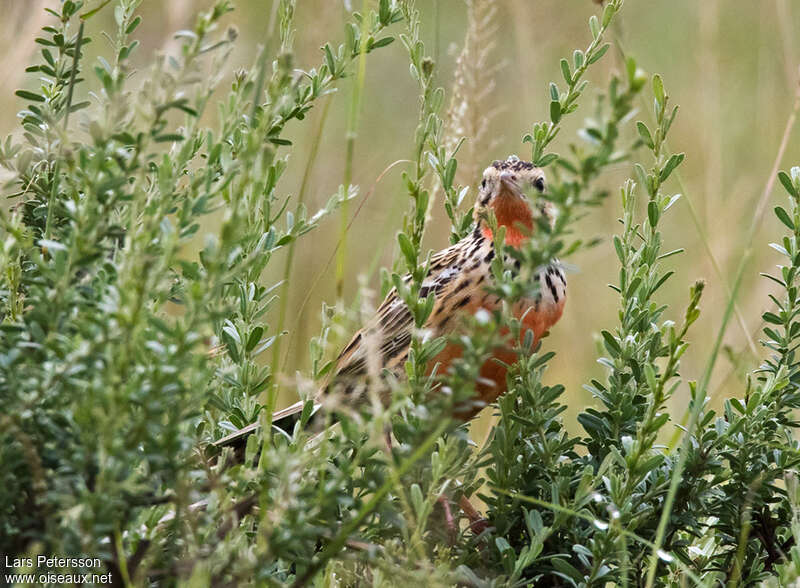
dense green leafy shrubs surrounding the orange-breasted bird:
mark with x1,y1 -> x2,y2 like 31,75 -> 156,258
0,0 -> 800,586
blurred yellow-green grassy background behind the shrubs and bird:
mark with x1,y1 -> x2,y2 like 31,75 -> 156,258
0,0 -> 800,431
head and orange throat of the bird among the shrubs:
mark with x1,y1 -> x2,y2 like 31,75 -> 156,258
475,155 -> 554,247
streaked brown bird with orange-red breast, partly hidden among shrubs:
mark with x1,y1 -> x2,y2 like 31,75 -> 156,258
216,155 -> 567,449
